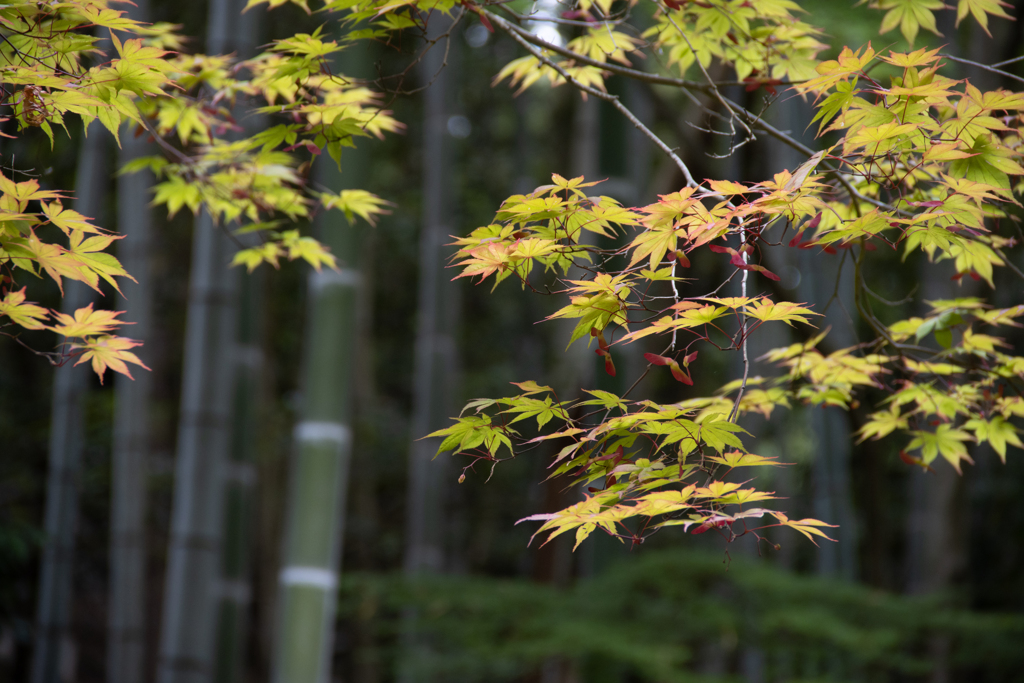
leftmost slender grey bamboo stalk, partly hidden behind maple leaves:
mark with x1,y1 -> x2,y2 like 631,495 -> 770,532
32,125 -> 109,683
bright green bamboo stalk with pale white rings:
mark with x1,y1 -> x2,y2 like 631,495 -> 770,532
271,54 -> 369,683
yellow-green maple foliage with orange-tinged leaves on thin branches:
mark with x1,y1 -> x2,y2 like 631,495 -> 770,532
0,0 -> 1024,589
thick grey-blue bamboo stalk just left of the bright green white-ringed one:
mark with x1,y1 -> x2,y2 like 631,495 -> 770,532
157,0 -> 239,683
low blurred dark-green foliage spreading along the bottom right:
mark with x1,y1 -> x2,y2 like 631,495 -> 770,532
342,549 -> 1024,683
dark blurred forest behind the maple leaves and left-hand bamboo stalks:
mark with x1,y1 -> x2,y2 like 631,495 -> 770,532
6,0 -> 1024,683
